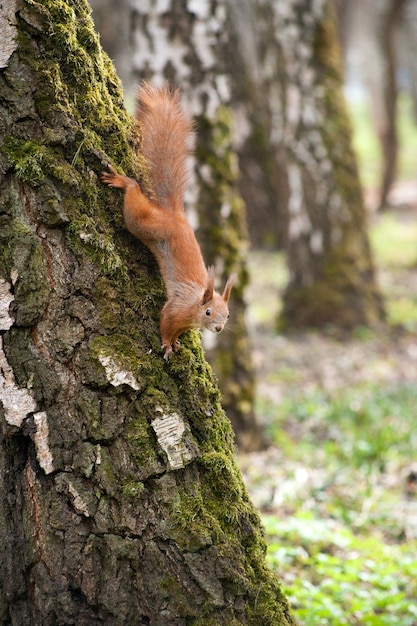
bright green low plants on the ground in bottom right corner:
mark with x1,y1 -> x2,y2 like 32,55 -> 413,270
264,512 -> 417,626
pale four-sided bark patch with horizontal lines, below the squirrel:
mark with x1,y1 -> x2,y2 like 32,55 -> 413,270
152,409 -> 194,470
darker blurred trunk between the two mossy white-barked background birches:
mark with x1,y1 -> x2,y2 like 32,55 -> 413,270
226,0 -> 288,249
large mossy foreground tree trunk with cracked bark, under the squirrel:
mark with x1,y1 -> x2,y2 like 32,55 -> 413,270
0,0 -> 294,626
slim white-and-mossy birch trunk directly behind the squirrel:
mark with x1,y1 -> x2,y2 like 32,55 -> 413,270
132,0 -> 264,450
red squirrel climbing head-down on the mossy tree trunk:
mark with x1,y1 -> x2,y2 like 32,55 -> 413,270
101,82 -> 236,361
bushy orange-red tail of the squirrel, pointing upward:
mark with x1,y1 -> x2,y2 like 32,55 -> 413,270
136,82 -> 193,211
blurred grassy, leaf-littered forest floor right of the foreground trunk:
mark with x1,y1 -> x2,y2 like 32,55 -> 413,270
239,205 -> 417,626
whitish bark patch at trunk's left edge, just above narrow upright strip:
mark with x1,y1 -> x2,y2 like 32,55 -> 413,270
0,337 -> 37,427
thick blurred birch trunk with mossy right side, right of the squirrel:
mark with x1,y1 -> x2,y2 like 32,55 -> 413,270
275,0 -> 383,329
